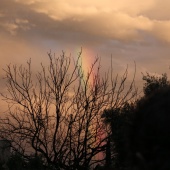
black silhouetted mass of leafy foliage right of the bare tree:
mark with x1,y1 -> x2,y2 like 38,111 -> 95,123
103,73 -> 170,170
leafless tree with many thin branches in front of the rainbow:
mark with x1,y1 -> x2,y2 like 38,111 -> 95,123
0,53 -> 136,170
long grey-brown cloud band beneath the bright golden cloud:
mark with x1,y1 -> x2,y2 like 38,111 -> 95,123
0,0 -> 154,43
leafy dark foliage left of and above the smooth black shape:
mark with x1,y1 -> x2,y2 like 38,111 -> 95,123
102,73 -> 170,169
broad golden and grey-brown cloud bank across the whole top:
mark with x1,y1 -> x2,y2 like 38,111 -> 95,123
0,0 -> 170,44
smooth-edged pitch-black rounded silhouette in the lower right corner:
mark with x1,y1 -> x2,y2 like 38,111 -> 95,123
130,87 -> 170,170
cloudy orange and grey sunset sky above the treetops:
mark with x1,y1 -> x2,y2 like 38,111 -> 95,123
0,0 -> 170,93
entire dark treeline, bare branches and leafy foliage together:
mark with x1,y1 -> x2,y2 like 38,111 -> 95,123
0,53 -> 170,170
